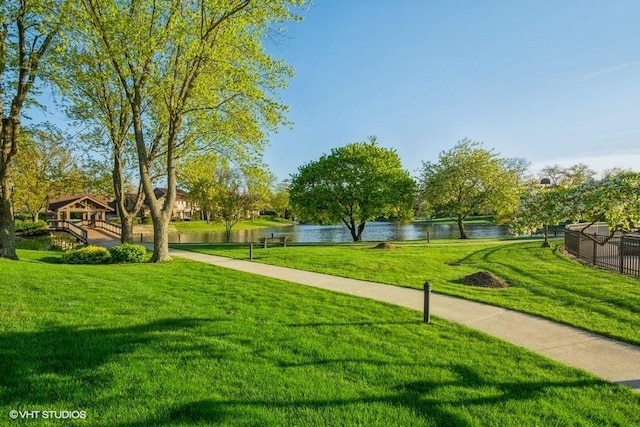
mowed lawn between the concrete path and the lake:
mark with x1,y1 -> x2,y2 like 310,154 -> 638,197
176,240 -> 640,345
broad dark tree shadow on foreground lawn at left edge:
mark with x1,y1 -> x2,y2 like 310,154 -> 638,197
0,318 -> 225,405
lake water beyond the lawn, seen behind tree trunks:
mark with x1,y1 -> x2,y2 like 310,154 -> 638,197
156,222 -> 509,243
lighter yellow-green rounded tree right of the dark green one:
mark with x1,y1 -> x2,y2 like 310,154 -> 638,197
419,138 -> 522,239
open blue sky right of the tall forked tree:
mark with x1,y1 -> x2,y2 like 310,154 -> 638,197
266,0 -> 640,179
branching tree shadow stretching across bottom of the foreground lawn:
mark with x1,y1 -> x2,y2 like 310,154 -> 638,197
112,365 -> 602,427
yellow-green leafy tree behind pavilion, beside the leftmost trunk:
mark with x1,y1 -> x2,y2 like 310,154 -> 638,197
13,128 -> 82,221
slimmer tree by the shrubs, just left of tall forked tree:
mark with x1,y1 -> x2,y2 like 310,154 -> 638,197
54,39 -> 145,243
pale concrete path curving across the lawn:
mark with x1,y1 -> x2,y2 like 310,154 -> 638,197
170,249 -> 640,391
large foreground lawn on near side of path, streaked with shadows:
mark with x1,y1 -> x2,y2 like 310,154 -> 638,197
0,251 -> 640,427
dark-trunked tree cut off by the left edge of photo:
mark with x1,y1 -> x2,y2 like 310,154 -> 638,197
0,0 -> 66,259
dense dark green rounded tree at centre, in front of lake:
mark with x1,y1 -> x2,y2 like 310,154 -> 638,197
289,137 -> 415,242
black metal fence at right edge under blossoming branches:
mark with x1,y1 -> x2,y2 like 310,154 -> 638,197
564,228 -> 640,277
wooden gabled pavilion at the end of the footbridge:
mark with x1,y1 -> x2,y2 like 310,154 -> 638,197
47,194 -> 114,221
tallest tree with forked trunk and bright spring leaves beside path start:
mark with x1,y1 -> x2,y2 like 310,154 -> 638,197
80,0 -> 303,262
